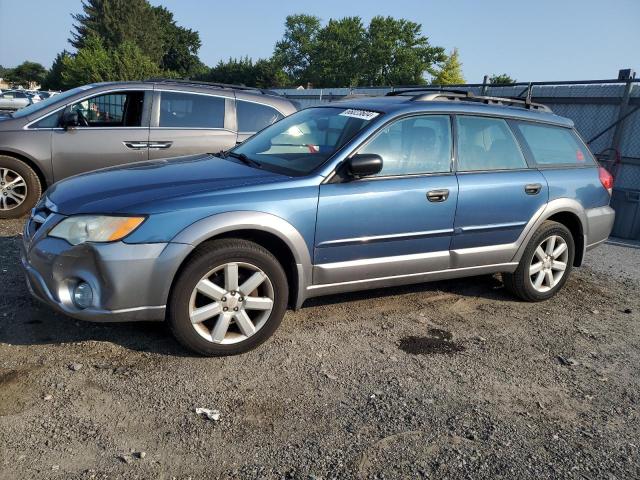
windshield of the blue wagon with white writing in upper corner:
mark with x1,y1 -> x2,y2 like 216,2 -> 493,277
233,107 -> 380,176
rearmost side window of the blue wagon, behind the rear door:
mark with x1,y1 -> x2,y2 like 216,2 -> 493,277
516,122 -> 593,165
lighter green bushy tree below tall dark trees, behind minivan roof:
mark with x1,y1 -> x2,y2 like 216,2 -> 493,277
62,36 -> 162,88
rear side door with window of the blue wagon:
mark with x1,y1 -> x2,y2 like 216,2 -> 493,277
451,115 -> 549,268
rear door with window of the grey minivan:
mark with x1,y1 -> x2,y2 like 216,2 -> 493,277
149,90 -> 236,159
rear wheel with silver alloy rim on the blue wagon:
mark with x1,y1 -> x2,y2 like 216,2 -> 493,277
502,220 -> 575,302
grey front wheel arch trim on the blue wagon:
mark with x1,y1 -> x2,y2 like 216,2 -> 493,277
171,211 -> 312,308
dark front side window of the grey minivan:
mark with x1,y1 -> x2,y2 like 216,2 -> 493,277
71,92 -> 144,127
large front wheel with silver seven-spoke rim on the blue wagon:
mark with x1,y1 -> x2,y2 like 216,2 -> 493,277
168,239 -> 289,356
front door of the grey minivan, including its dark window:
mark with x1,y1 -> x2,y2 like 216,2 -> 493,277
51,90 -> 151,181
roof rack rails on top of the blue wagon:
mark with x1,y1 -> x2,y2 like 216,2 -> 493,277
387,88 -> 552,112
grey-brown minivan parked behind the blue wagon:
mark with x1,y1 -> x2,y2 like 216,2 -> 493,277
0,80 -> 296,218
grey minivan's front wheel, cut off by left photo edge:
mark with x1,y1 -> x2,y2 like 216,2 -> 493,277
0,155 -> 42,219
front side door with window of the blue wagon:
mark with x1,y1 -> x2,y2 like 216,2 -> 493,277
313,115 -> 458,284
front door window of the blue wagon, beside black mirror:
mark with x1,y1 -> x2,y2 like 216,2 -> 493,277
359,115 -> 452,176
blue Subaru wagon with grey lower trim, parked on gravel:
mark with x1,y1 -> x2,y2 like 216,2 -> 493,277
22,90 -> 614,355
